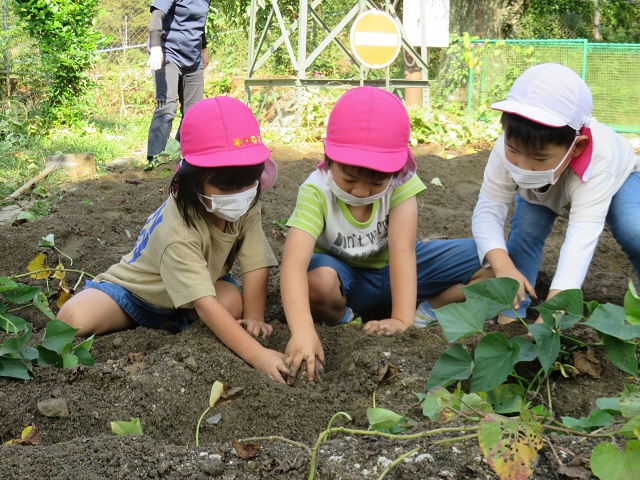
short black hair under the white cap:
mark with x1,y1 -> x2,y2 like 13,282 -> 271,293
500,112 -> 576,152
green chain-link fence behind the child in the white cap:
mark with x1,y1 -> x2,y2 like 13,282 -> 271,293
457,40 -> 640,133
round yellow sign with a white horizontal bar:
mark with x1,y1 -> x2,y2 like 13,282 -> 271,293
351,10 -> 401,68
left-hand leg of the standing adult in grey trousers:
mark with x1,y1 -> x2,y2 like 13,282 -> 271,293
147,62 -> 181,158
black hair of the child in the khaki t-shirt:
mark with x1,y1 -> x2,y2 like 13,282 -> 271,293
169,160 -> 264,227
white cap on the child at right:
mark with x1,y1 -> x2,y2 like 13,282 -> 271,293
491,63 -> 593,130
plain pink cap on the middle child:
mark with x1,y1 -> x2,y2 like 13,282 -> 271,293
324,87 -> 416,179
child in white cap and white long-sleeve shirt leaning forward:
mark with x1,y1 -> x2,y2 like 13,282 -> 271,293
473,63 -> 640,323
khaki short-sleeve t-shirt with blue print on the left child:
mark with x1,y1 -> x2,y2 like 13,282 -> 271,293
95,196 -> 278,309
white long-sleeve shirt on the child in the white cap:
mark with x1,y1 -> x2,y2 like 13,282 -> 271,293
472,120 -> 640,290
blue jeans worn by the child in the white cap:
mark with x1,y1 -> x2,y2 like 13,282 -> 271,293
503,172 -> 640,318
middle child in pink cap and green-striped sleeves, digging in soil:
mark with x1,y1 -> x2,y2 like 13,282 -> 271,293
280,87 -> 487,380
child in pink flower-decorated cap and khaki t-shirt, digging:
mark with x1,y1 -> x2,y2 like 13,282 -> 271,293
58,97 -> 288,382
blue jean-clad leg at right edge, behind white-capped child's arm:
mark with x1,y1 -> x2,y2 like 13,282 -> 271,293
607,172 -> 640,277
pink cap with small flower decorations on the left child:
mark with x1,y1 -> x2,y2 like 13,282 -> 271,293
180,96 -> 278,190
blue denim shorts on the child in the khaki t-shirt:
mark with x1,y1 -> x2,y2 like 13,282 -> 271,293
84,275 -> 240,333
